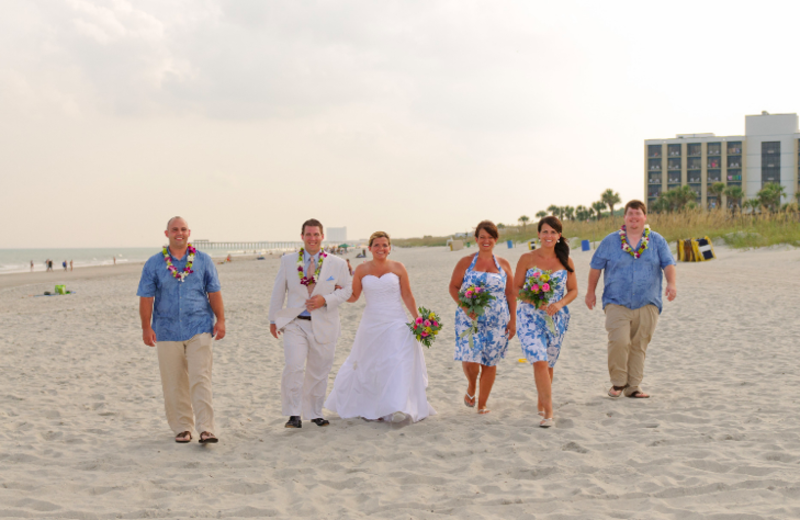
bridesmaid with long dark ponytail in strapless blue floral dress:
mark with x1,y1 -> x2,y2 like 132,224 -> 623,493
514,216 -> 578,428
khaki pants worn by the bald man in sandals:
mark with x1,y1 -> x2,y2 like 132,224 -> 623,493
156,333 -> 216,435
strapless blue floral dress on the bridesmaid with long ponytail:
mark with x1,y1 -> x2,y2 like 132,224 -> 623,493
517,267 -> 569,368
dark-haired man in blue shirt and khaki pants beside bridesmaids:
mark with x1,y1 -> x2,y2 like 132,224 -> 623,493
586,200 -> 677,398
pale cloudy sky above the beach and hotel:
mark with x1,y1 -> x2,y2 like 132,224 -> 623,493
0,0 -> 800,249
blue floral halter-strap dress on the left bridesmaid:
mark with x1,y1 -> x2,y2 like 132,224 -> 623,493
454,254 -> 511,367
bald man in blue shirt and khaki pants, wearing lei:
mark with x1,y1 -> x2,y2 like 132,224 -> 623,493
136,217 -> 225,444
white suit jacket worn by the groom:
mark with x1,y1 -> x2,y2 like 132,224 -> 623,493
269,253 -> 353,343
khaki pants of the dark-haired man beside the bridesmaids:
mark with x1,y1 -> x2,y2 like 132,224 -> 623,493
605,304 -> 658,395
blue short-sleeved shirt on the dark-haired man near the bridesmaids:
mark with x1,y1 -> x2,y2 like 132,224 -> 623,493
590,231 -> 675,313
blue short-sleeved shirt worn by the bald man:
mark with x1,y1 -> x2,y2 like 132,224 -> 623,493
136,250 -> 222,341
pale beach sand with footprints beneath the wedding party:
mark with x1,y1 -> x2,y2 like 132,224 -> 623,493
0,247 -> 800,520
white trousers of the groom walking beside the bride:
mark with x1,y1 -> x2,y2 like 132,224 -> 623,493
281,319 -> 336,420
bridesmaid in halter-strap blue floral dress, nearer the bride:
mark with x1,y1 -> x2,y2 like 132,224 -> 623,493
450,220 -> 517,414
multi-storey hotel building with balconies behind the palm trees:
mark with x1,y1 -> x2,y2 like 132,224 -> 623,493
644,112 -> 800,208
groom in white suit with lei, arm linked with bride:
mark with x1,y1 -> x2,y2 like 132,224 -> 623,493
269,219 -> 353,428
